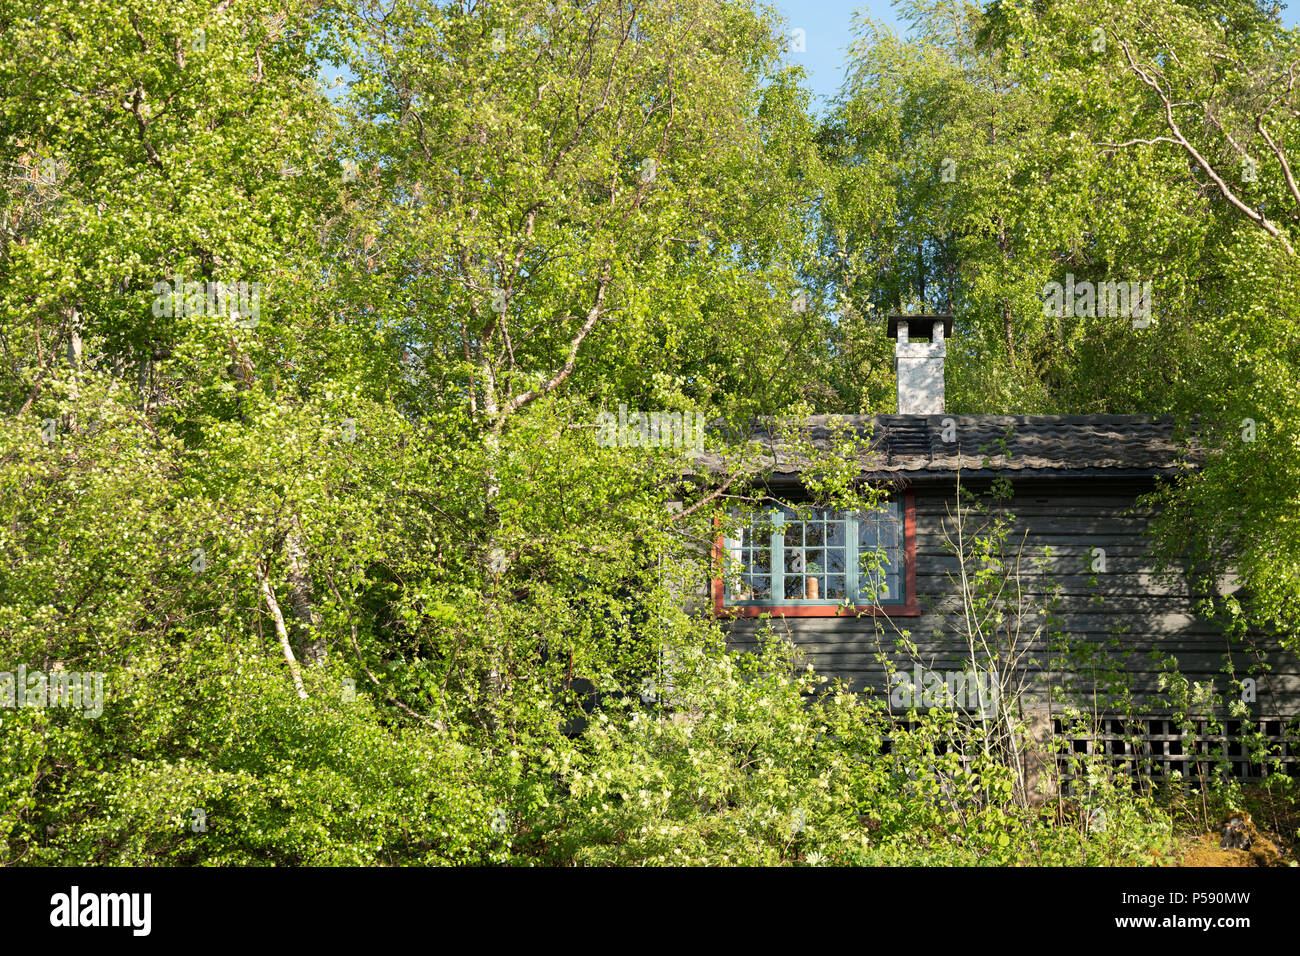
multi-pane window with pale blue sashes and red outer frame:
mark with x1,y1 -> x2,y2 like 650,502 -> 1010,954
714,493 -> 917,617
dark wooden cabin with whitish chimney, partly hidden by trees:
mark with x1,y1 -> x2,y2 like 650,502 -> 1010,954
703,316 -> 1300,777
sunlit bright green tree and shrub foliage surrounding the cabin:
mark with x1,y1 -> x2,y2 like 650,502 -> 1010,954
0,0 -> 1300,865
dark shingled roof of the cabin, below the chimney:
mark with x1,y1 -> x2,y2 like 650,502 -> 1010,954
697,415 -> 1200,481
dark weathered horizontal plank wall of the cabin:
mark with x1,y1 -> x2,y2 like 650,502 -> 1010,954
725,480 -> 1300,717
